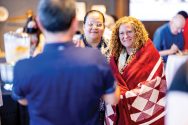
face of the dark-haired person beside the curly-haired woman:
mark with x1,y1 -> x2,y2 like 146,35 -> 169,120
83,12 -> 104,41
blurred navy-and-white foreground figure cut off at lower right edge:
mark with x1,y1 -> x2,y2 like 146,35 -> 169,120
165,61 -> 188,125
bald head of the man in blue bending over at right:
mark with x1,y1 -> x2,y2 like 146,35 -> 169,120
170,14 -> 185,35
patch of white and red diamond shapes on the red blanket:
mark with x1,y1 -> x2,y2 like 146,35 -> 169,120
126,77 -> 165,122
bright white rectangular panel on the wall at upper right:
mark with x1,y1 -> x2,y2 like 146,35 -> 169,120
129,0 -> 188,21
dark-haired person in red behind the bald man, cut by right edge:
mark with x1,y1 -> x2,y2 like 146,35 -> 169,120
178,11 -> 188,51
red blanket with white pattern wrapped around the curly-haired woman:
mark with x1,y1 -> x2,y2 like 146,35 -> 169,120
106,40 -> 167,125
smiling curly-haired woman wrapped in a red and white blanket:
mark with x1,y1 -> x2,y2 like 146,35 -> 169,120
106,16 -> 167,125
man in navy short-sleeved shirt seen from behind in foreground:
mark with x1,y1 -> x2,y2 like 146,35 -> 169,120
12,0 -> 119,125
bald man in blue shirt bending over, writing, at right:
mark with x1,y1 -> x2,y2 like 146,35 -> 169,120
153,14 -> 185,63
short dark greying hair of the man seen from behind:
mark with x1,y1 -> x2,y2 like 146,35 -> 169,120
38,0 -> 76,32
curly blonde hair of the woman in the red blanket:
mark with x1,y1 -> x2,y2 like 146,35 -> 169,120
110,16 -> 148,60
